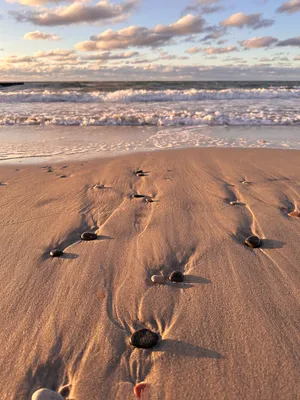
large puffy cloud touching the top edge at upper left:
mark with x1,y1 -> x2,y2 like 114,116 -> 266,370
10,0 -> 138,26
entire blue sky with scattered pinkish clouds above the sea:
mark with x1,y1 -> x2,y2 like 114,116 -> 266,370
0,0 -> 300,81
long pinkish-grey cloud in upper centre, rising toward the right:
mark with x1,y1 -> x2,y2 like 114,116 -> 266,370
75,14 -> 205,51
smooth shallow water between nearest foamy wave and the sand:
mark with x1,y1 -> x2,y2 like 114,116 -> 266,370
0,126 -> 300,163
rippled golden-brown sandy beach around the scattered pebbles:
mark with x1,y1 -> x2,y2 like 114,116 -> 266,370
0,148 -> 300,400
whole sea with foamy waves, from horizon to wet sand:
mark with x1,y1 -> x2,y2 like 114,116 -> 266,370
0,81 -> 300,163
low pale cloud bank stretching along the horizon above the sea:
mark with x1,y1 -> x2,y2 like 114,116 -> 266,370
0,62 -> 300,81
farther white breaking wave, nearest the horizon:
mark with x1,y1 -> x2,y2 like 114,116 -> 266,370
0,87 -> 300,103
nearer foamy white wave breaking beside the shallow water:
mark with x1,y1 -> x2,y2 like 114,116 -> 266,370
0,110 -> 300,126
